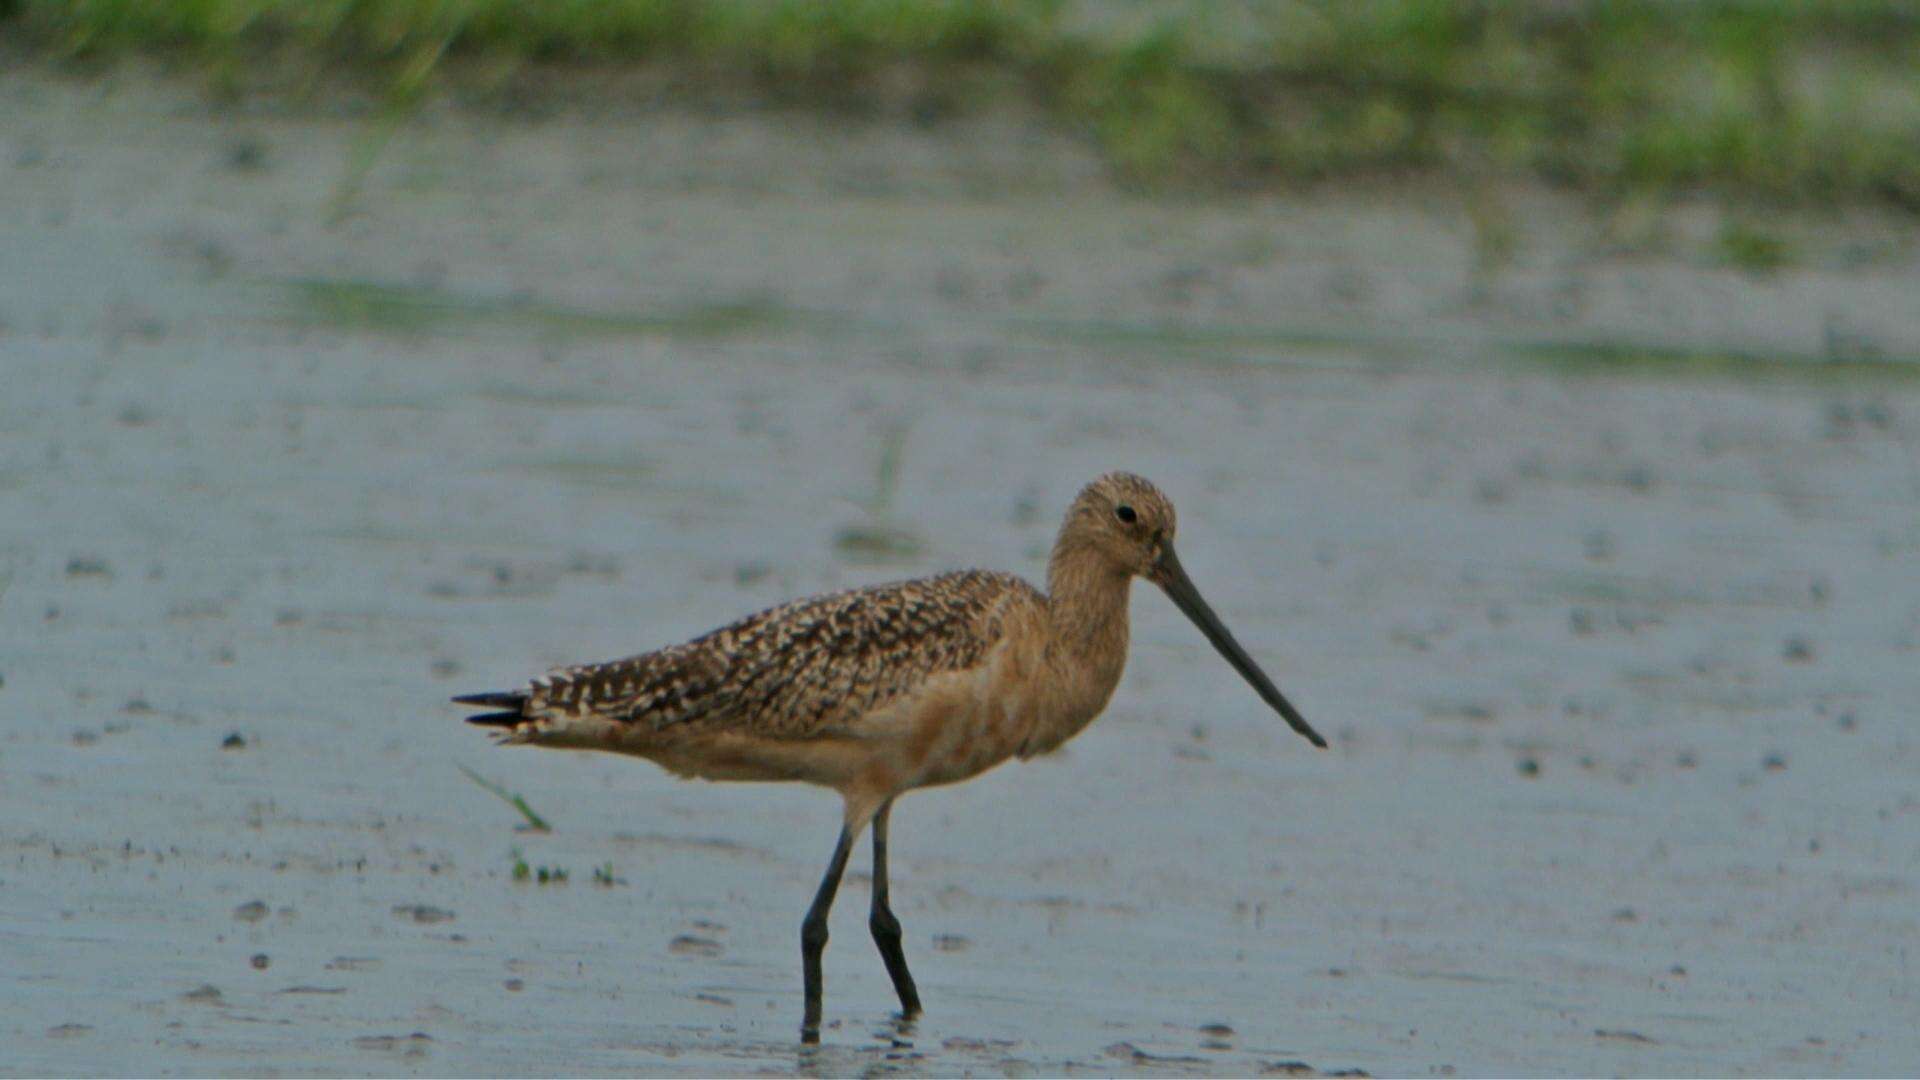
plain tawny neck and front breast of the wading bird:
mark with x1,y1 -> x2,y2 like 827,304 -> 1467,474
1046,536 -> 1133,724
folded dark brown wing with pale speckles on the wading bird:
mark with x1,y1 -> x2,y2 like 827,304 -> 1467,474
524,571 -> 1041,738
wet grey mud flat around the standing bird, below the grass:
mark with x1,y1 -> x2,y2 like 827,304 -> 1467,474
0,71 -> 1920,1076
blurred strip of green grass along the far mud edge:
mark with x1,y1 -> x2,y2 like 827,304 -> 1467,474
11,0 -> 1920,213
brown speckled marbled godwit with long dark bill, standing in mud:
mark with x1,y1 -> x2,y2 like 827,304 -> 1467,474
455,473 -> 1327,1042
